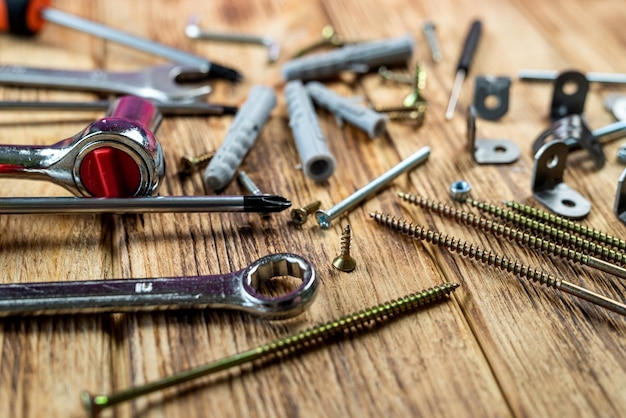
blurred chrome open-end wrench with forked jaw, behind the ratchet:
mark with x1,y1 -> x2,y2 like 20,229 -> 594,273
0,64 -> 211,103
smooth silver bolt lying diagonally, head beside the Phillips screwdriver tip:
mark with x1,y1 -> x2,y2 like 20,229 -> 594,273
315,147 -> 430,229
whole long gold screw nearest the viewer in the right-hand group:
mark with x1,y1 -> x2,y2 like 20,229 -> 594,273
370,212 -> 626,316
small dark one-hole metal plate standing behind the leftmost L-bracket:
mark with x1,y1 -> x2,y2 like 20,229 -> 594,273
474,76 -> 511,120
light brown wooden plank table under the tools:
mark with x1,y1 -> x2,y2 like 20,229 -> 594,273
0,0 -> 626,418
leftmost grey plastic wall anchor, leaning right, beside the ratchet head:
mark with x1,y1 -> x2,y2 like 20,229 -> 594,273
204,86 -> 276,191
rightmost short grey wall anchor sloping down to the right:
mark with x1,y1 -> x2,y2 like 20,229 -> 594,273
305,81 -> 387,138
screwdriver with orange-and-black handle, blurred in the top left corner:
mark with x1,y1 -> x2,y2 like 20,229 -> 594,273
0,0 -> 242,81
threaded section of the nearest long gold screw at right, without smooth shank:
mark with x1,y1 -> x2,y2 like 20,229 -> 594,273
370,212 -> 561,289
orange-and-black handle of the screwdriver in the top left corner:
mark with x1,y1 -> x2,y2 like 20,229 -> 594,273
0,0 -> 50,35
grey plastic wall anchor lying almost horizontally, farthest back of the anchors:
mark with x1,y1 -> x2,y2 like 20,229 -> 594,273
281,35 -> 415,81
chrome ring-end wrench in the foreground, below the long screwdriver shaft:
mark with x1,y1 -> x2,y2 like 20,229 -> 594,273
0,253 -> 319,319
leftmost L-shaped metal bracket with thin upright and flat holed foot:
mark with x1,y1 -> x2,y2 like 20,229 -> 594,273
467,106 -> 520,164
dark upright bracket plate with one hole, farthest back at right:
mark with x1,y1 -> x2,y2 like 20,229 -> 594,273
550,71 -> 589,121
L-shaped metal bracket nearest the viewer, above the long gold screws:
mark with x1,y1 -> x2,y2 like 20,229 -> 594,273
531,141 -> 591,219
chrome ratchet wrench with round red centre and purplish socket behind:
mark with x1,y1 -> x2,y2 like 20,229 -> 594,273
0,96 -> 165,197
